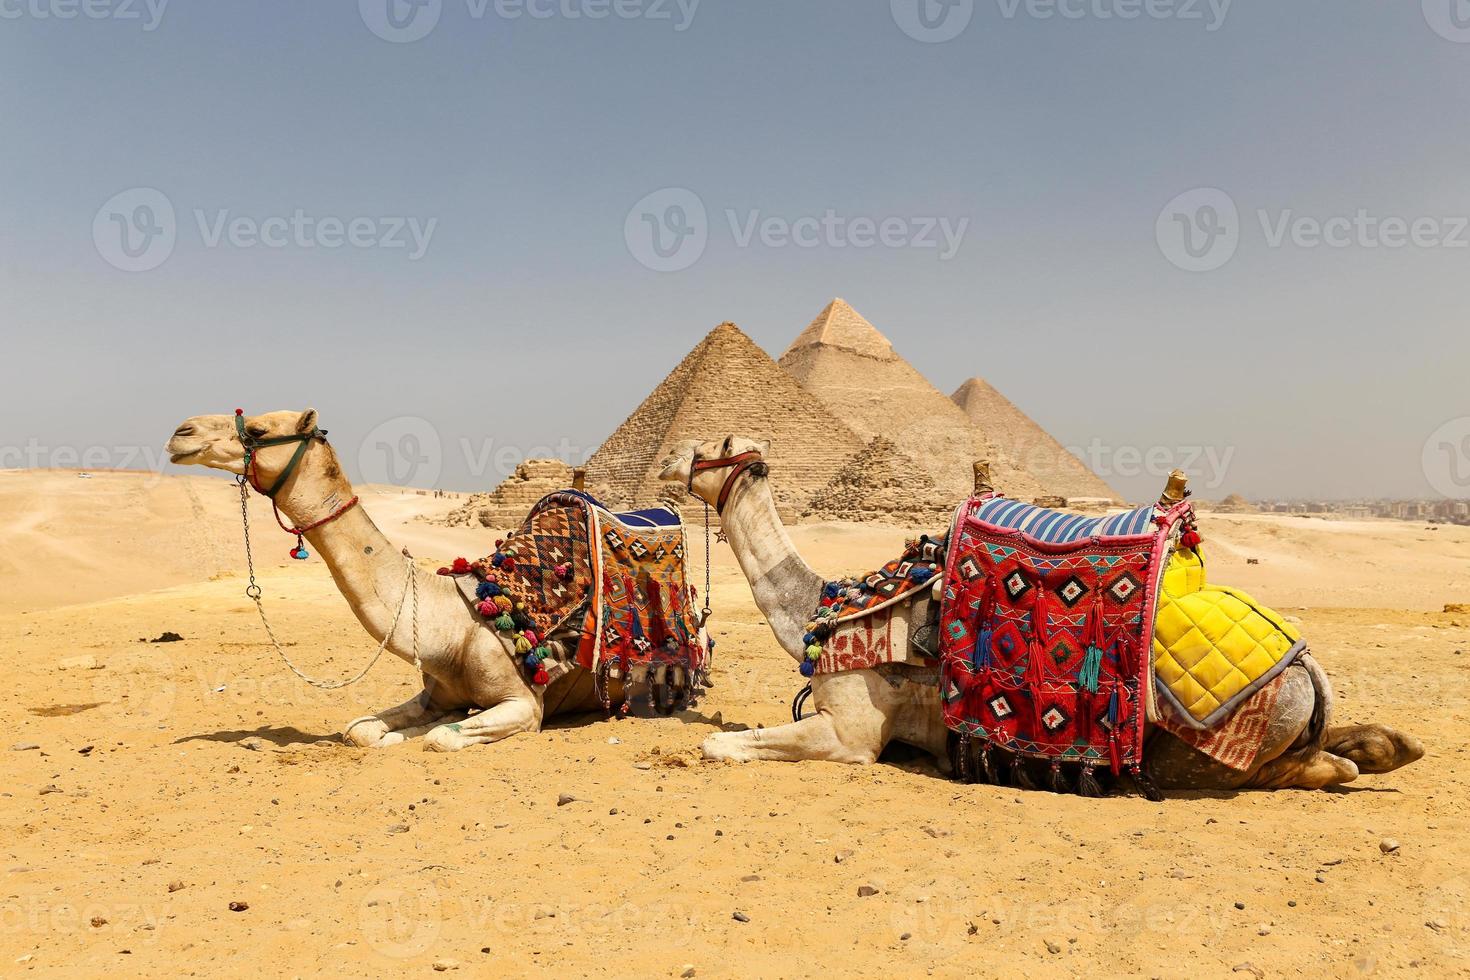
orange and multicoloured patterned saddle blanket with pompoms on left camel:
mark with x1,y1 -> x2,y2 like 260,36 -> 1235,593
440,491 -> 707,705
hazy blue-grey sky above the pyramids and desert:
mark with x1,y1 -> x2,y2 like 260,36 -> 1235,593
0,0 -> 1470,497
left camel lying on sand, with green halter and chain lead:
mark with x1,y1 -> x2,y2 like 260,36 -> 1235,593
168,408 -> 664,752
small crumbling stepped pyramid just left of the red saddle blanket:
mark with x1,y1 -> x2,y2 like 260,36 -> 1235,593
801,436 -> 951,523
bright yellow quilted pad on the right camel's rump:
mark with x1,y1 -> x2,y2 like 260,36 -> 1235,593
1154,548 -> 1305,729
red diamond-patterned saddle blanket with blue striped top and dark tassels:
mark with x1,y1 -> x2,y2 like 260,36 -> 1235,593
939,495 -> 1194,792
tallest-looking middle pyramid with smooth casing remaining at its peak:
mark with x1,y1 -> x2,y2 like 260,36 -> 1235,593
781,300 -> 1051,505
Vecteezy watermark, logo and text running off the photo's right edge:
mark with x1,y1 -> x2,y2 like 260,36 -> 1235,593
1154,187 -> 1470,272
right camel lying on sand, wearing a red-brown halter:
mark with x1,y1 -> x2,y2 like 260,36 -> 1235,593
662,436 -> 1424,790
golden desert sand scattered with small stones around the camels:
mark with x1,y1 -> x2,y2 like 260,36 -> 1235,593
0,472 -> 1470,979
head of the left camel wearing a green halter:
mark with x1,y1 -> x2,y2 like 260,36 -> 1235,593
166,408 -> 343,491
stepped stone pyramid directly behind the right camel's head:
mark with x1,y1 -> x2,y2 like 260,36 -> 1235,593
587,323 -> 863,520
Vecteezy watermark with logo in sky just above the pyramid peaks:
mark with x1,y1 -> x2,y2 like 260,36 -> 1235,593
623,187 -> 970,272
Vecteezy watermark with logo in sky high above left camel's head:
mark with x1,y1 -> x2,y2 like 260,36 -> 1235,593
93,187 -> 440,272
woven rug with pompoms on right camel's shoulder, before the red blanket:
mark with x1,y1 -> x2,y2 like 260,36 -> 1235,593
801,535 -> 947,677
